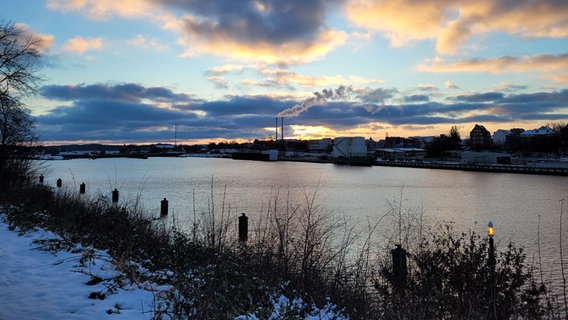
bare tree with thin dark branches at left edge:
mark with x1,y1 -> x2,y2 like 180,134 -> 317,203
0,20 -> 42,172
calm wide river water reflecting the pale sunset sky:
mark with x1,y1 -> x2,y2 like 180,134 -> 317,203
44,158 -> 568,296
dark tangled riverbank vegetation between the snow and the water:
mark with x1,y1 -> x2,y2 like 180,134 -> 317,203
0,160 -> 566,319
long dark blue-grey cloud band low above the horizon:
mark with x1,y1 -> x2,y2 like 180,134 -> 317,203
35,83 -> 568,143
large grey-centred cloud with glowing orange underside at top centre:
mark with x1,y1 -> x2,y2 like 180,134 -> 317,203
48,0 -> 348,65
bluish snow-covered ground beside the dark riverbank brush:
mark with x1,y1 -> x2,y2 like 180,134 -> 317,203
0,214 -> 345,320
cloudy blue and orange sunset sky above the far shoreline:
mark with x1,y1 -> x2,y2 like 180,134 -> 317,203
0,0 -> 568,144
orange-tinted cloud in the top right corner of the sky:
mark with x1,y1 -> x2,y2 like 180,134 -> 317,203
345,0 -> 568,54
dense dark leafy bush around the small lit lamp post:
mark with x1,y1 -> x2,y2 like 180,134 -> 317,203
375,227 -> 547,319
